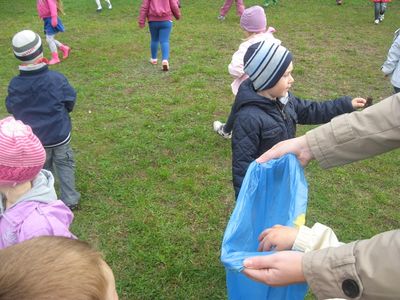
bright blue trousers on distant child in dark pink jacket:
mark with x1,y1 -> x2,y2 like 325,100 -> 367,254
149,21 -> 172,60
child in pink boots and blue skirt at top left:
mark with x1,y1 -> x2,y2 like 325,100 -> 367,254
36,0 -> 71,65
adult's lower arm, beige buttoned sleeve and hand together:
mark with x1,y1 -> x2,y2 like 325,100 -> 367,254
243,230 -> 400,300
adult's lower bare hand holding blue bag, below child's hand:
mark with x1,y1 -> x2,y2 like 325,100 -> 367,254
242,251 -> 306,286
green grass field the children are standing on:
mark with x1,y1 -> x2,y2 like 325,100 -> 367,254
0,0 -> 400,299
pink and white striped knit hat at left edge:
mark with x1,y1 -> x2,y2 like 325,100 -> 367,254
0,117 -> 46,186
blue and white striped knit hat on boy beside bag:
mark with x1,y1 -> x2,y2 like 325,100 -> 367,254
244,41 -> 292,91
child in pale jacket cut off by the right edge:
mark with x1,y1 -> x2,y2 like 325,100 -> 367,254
382,28 -> 400,93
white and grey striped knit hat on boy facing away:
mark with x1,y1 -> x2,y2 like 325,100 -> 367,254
12,30 -> 43,64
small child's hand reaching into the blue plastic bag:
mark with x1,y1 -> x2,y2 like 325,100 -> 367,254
257,225 -> 299,251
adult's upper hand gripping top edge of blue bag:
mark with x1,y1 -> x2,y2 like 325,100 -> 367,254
256,135 -> 314,167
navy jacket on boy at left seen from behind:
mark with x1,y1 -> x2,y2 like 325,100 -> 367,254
6,66 -> 76,148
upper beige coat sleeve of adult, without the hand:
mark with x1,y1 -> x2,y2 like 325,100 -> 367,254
306,94 -> 400,168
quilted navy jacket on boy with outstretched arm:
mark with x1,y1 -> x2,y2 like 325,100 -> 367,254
232,79 -> 354,197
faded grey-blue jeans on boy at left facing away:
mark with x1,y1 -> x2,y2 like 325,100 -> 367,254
44,143 -> 81,206
